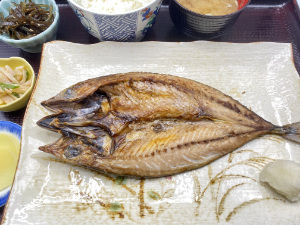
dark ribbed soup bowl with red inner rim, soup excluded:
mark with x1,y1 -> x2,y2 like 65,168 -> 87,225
169,0 -> 250,39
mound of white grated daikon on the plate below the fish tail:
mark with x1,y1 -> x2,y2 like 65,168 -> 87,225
259,160 -> 300,202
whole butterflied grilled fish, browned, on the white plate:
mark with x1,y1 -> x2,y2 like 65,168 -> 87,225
38,72 -> 300,177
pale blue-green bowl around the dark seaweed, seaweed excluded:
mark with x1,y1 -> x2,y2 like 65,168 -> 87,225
0,0 -> 59,53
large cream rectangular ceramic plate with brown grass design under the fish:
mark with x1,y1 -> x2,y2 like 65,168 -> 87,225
3,41 -> 300,225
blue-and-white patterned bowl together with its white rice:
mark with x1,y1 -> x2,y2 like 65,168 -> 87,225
68,0 -> 162,41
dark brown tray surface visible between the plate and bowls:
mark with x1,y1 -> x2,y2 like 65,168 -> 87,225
0,0 -> 300,220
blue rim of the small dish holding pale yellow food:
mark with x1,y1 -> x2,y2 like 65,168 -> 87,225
0,121 -> 22,207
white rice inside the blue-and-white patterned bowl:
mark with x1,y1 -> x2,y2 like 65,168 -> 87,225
74,0 -> 153,13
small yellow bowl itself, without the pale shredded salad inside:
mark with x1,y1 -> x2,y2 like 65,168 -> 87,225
0,57 -> 36,112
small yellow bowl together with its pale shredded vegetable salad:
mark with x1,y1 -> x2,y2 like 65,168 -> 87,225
0,57 -> 36,112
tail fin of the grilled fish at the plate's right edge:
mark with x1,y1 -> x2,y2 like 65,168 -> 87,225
272,122 -> 300,144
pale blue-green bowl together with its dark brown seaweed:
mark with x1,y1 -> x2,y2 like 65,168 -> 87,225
0,0 -> 59,53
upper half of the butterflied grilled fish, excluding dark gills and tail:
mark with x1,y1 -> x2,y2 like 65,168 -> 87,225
41,73 -> 269,127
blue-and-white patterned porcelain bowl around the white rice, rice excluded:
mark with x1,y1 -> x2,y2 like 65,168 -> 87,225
68,0 -> 162,41
